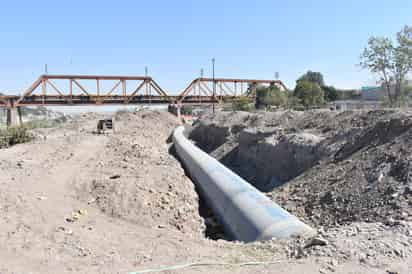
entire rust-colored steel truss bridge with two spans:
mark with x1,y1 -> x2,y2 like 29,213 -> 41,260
0,75 -> 286,108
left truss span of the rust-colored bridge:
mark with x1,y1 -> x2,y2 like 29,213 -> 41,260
11,75 -> 170,106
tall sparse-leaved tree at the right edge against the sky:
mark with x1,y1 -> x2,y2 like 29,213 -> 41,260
360,26 -> 412,106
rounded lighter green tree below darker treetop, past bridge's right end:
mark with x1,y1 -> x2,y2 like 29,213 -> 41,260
293,80 -> 324,108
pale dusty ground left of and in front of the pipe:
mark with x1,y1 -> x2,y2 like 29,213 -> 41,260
0,111 -> 412,273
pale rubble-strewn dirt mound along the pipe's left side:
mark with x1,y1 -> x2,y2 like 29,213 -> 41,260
78,111 -> 203,233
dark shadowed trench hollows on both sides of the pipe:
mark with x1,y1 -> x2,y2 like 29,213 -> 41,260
174,125 -> 320,240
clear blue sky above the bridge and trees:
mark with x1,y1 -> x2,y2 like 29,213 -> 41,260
0,0 -> 412,93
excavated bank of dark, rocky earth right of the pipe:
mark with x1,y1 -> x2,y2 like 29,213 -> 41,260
191,110 -> 412,226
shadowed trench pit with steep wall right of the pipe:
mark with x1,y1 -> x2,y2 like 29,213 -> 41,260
189,124 -> 328,192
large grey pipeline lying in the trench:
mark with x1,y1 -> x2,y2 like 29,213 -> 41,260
173,126 -> 315,242
